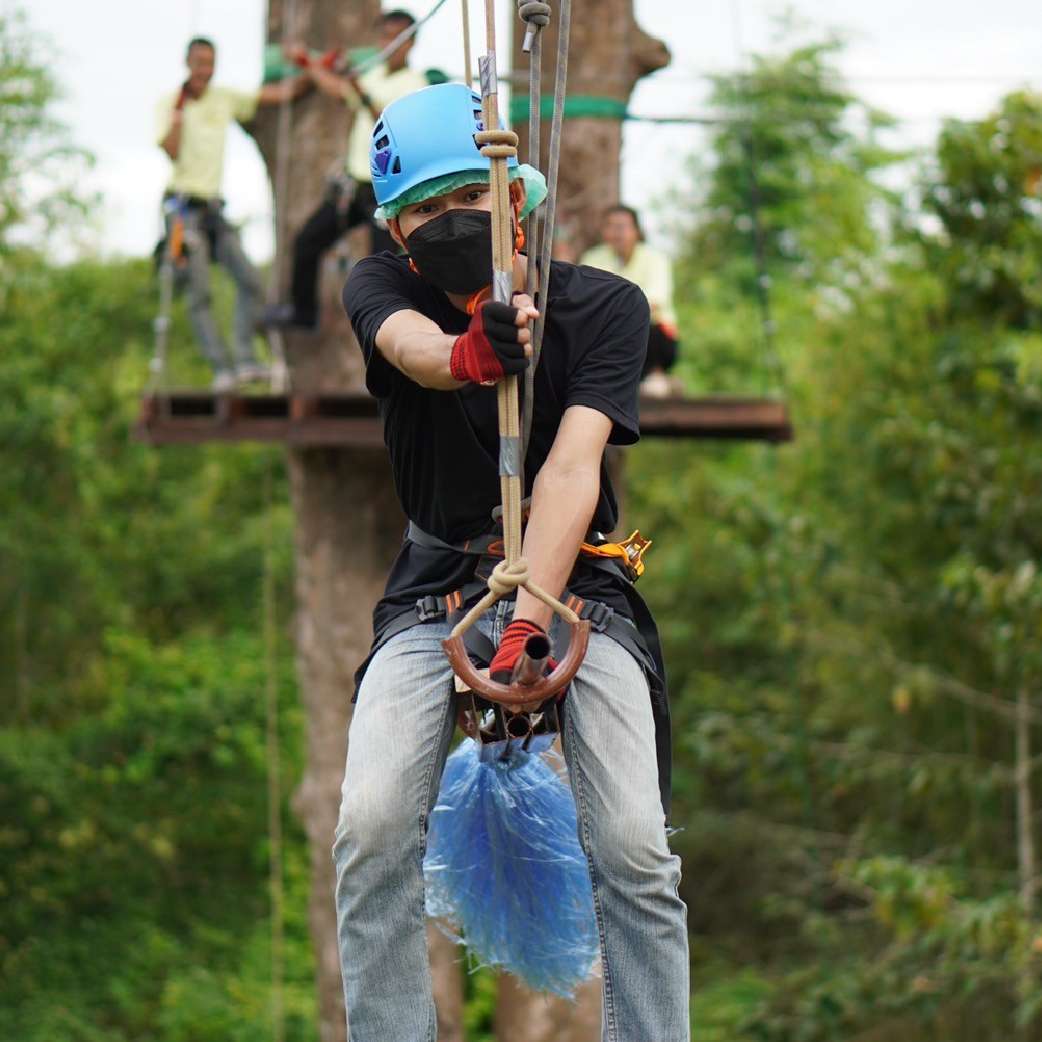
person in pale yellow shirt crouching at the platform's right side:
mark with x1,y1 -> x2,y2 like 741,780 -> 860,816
579,203 -> 678,396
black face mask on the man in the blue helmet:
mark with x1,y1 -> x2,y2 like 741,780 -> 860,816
405,209 -> 492,296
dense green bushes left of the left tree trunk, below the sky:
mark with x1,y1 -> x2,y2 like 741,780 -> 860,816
0,247 -> 315,1042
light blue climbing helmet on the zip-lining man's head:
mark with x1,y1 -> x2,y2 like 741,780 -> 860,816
369,83 -> 518,206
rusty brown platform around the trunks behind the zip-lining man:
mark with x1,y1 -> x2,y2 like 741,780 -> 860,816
134,391 -> 792,447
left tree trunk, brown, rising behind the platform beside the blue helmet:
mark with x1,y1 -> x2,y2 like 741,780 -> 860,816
251,0 -> 463,1042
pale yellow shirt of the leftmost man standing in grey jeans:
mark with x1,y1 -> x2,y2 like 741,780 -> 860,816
155,84 -> 261,199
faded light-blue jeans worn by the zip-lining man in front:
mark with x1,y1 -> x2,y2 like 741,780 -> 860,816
333,601 -> 690,1042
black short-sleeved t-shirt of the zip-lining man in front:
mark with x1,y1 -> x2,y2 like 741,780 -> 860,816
344,253 -> 649,635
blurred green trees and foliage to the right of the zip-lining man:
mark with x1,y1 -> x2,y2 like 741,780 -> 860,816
630,28 -> 1042,1042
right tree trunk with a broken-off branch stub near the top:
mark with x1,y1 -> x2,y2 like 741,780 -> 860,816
496,6 -> 669,1042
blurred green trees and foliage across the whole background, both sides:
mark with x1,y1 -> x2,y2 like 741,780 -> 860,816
0,8 -> 1042,1042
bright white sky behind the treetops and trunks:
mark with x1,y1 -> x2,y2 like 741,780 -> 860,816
16,0 -> 1042,262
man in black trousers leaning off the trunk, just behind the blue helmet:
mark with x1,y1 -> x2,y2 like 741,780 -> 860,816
265,10 -> 429,329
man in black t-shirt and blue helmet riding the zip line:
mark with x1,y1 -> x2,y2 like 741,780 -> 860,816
333,83 -> 690,1042
